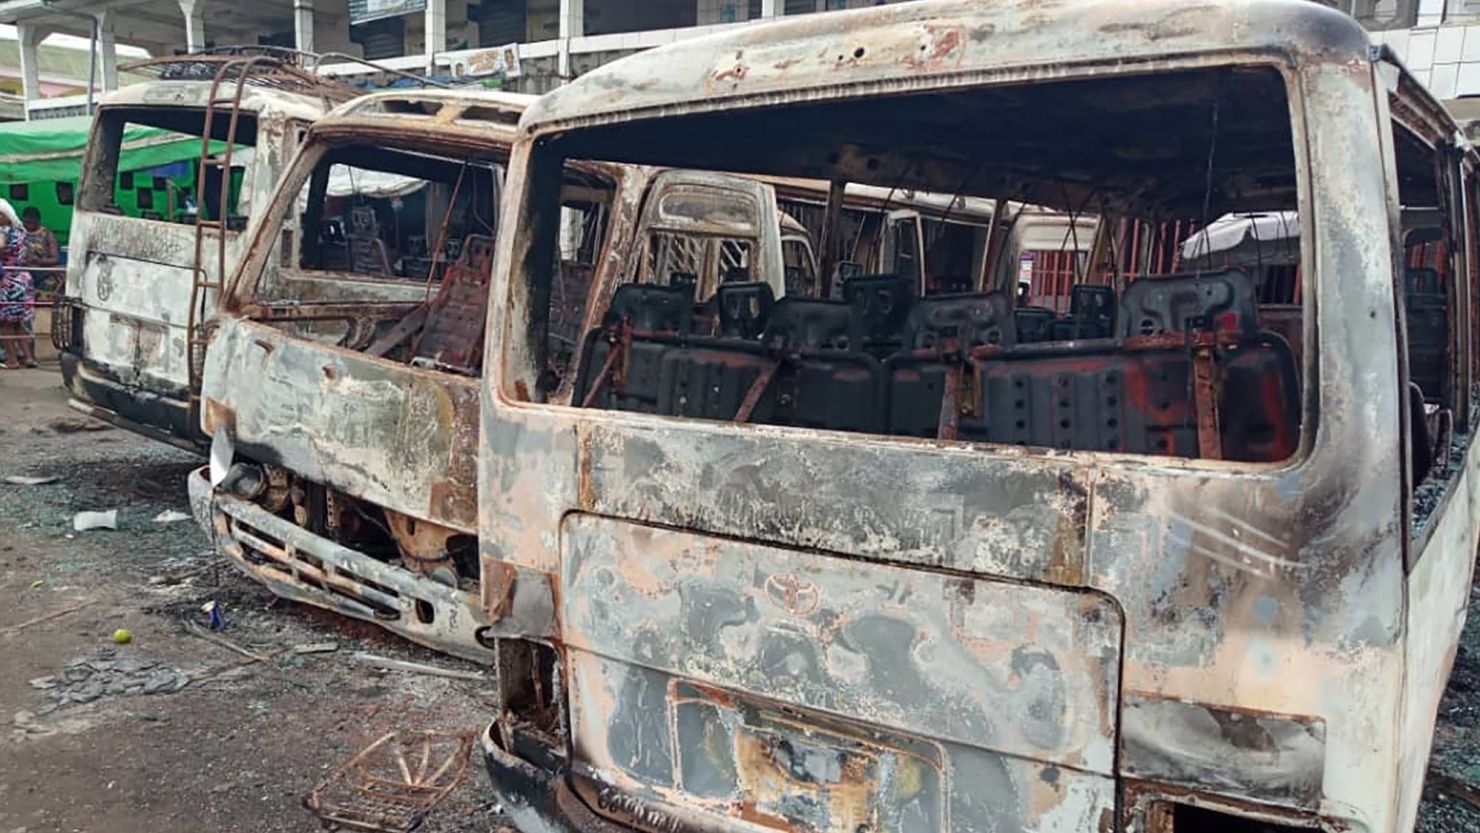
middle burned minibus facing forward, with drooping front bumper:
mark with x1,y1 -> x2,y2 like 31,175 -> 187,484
191,90 -> 815,661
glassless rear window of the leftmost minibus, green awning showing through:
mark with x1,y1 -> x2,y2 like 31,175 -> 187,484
78,108 -> 258,231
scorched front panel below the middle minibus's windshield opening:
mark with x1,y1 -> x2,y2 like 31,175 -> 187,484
203,317 -> 478,533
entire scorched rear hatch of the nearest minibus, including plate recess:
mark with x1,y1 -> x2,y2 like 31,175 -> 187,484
561,515 -> 1120,833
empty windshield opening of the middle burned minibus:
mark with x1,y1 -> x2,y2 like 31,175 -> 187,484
247,141 -> 614,376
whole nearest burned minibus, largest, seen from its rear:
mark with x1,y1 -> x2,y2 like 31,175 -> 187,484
478,0 -> 1480,833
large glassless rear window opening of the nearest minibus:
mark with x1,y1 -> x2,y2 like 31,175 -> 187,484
517,68 -> 1304,463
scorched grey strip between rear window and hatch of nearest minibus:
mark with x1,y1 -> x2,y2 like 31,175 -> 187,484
571,426 -> 1088,584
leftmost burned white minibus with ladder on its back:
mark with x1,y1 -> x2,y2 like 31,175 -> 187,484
53,56 -> 354,450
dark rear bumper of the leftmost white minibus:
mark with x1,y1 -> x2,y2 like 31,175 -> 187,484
59,351 -> 206,453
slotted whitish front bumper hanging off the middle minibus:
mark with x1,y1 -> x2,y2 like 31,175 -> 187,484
189,468 -> 493,663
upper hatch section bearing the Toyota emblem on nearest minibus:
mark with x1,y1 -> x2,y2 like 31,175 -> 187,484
561,515 -> 1120,774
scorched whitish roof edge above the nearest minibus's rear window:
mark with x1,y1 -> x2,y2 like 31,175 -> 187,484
521,0 -> 1370,132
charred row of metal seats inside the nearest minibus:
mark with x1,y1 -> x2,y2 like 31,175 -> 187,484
574,275 -> 1299,462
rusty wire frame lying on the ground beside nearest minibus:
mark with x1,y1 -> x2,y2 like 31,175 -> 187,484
303,732 -> 474,833
